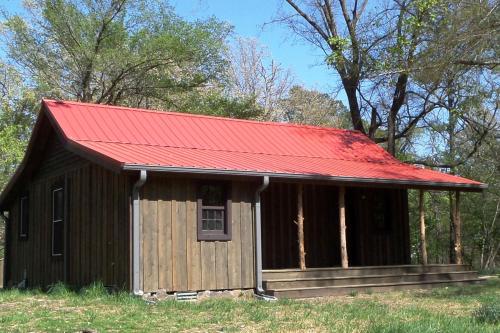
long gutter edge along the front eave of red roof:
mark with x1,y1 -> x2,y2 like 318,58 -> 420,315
123,163 -> 488,192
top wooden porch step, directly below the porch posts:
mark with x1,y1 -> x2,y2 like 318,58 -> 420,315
262,264 -> 471,280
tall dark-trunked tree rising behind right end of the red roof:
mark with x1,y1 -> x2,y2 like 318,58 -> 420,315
277,0 -> 496,155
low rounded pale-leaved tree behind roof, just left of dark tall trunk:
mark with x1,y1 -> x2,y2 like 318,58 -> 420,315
281,86 -> 350,128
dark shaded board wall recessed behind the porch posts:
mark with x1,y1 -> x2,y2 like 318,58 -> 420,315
262,183 -> 410,269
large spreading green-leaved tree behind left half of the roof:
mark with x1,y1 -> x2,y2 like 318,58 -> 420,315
4,0 -> 231,107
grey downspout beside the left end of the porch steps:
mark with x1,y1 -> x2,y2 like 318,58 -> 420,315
255,176 -> 276,301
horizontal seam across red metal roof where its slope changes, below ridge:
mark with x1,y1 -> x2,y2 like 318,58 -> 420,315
79,138 -> 402,165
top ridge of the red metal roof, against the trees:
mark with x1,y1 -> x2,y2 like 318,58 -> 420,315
42,99 -> 364,136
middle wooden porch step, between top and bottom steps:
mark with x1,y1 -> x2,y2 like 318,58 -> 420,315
264,271 -> 477,290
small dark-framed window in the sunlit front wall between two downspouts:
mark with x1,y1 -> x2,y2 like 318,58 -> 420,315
198,182 -> 231,241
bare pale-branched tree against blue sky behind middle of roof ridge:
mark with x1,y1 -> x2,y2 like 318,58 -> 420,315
229,38 -> 293,120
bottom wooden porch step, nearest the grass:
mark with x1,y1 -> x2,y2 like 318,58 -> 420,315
266,278 -> 485,298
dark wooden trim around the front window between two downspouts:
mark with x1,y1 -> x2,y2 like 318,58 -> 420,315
196,181 -> 233,241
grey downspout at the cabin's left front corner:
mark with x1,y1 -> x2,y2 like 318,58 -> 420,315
132,170 -> 147,296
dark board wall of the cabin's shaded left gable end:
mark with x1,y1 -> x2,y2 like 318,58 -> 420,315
7,134 -> 130,288
